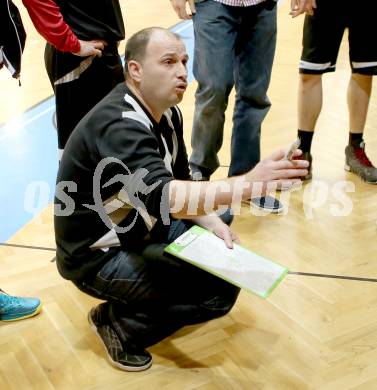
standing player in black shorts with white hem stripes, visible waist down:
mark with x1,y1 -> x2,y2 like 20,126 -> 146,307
298,0 -> 377,184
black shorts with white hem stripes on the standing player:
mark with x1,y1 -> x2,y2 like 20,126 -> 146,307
300,0 -> 377,75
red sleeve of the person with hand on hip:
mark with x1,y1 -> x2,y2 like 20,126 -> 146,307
22,0 -> 80,53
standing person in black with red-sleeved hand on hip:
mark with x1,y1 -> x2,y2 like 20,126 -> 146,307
23,0 -> 125,157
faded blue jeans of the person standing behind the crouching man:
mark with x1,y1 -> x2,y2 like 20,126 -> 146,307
190,0 -> 276,176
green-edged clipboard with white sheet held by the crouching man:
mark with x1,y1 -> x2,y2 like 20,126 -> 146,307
165,225 -> 288,298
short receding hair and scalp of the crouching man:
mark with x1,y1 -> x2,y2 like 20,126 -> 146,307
124,27 -> 181,76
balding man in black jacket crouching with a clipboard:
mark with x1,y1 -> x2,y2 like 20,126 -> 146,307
55,28 -> 308,371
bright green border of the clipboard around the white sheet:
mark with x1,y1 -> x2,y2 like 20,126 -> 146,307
164,225 -> 289,299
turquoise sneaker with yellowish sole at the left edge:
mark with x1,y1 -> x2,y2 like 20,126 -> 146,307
0,290 -> 42,321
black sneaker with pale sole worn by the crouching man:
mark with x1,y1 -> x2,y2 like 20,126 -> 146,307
88,305 -> 152,371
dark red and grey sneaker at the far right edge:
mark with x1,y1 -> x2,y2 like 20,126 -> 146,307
344,141 -> 377,184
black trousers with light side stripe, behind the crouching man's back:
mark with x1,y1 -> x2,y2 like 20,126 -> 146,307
45,43 -> 124,152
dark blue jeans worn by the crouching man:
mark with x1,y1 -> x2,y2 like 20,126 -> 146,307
75,217 -> 239,348
